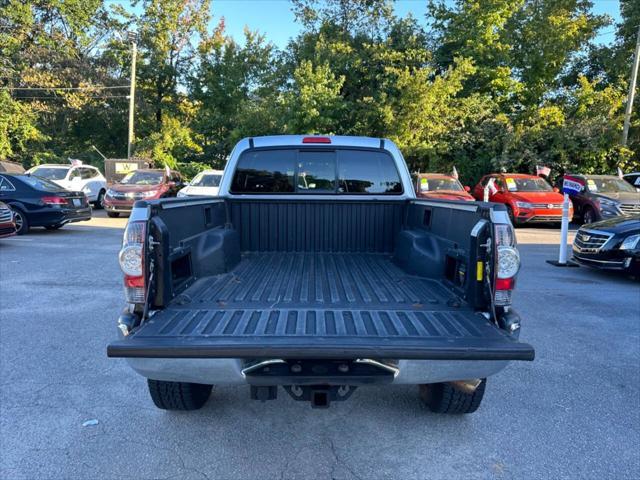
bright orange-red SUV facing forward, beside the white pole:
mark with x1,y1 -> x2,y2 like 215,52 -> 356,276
473,173 -> 573,225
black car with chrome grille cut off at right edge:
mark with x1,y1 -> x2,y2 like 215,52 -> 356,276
573,215 -> 640,275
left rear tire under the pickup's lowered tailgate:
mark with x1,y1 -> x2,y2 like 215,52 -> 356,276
147,379 -> 213,410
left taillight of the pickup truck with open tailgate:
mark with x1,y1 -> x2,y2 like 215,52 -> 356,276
118,222 -> 146,303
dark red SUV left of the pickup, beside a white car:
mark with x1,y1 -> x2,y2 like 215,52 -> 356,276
103,169 -> 183,217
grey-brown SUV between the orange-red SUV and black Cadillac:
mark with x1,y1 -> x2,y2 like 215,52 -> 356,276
558,174 -> 640,224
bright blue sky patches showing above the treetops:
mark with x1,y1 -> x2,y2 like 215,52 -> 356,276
212,0 -> 620,48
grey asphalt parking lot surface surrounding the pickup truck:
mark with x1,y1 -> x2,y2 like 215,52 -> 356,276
0,212 -> 640,479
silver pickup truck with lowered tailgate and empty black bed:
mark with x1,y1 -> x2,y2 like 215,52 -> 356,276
107,136 -> 534,413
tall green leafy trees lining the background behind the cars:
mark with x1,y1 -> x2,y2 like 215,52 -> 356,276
0,0 -> 640,176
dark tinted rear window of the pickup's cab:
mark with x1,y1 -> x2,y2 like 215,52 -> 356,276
231,149 -> 403,195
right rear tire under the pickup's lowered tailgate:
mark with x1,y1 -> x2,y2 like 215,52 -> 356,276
420,378 -> 487,415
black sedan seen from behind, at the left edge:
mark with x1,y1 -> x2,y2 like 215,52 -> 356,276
0,173 -> 91,235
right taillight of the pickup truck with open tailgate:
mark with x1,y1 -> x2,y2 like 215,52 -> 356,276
494,224 -> 520,306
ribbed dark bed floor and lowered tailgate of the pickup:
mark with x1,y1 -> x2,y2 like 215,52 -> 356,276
108,252 -> 533,360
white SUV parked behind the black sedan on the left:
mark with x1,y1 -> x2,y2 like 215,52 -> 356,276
27,164 -> 107,208
